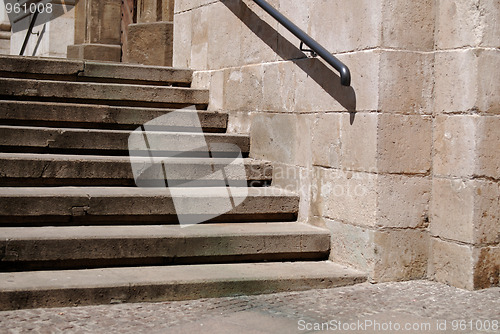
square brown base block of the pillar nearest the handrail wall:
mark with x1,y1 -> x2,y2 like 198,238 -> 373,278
127,22 -> 174,66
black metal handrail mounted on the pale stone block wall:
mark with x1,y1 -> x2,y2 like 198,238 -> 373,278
253,0 -> 351,86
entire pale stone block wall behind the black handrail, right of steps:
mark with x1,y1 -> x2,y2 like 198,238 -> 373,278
174,0 -> 500,289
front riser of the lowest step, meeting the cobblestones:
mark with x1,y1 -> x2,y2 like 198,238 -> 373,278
0,277 -> 366,311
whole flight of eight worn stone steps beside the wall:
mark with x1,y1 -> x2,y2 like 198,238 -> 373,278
0,56 -> 366,310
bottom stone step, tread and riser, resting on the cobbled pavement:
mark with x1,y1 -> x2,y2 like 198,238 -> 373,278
0,261 -> 366,310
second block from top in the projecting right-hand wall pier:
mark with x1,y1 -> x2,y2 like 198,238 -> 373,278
434,49 -> 500,114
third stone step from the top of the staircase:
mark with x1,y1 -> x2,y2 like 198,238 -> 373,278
0,100 -> 228,132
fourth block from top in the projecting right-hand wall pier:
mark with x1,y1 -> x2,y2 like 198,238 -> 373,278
430,178 -> 500,244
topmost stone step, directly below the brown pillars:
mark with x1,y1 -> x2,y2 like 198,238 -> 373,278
0,55 -> 193,86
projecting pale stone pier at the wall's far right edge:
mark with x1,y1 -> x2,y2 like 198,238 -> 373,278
429,0 -> 500,289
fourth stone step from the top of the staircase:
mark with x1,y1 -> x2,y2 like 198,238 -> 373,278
0,125 -> 250,156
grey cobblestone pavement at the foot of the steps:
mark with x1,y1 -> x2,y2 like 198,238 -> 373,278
0,281 -> 500,334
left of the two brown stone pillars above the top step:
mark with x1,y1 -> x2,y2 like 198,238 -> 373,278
68,0 -> 121,61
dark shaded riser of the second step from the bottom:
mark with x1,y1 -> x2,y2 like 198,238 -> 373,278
0,236 -> 330,271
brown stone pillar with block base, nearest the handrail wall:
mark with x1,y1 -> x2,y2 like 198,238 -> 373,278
127,0 -> 174,66
